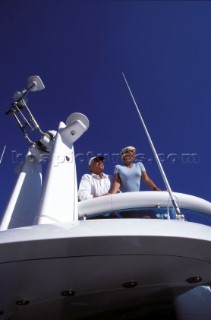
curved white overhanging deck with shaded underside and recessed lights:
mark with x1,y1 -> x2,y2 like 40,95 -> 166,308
0,219 -> 211,320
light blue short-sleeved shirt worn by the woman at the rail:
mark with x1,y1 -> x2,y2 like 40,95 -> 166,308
114,162 -> 146,192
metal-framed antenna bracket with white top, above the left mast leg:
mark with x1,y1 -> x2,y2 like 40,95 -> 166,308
5,76 -> 45,144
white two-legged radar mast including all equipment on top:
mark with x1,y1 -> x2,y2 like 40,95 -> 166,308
0,76 -> 89,230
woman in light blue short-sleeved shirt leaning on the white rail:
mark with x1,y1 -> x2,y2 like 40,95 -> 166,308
111,146 -> 160,193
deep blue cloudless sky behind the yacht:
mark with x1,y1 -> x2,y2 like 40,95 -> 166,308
0,0 -> 211,218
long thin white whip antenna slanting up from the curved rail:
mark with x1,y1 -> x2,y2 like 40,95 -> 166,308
122,72 -> 184,220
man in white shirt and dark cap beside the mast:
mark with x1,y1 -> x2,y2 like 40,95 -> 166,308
78,156 -> 111,201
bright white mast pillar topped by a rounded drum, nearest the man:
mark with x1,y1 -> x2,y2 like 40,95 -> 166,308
37,112 -> 89,224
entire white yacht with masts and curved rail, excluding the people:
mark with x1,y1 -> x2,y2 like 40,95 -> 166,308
0,77 -> 211,320
